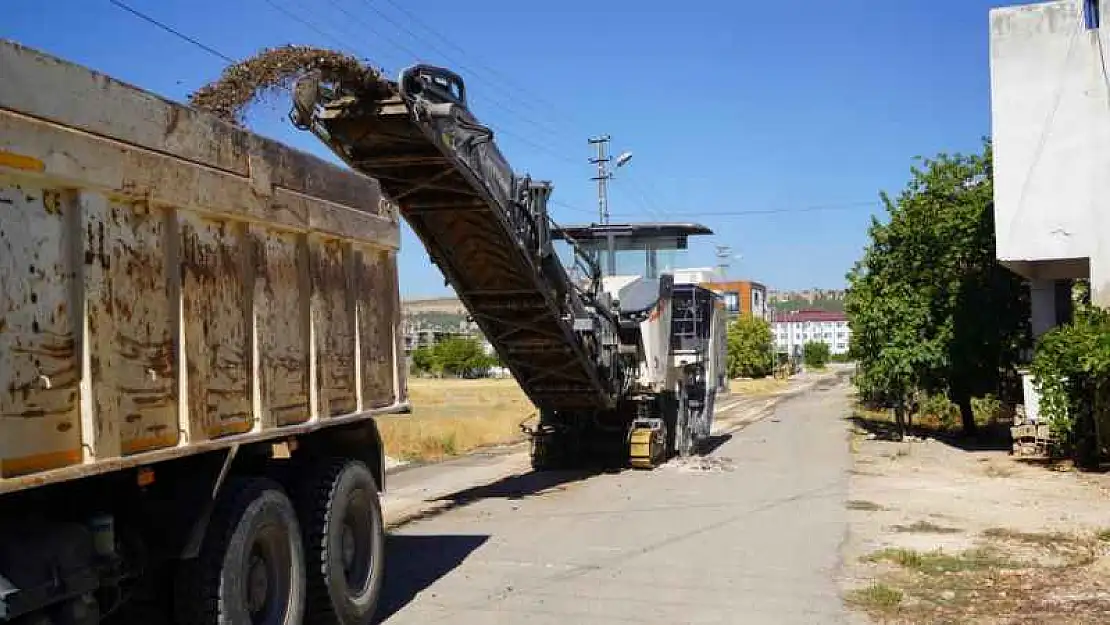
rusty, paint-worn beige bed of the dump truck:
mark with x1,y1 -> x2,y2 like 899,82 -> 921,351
0,41 -> 406,493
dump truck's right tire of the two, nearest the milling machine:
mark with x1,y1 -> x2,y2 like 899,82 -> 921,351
296,458 -> 385,625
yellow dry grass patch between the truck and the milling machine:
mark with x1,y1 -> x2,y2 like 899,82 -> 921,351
377,379 -> 535,461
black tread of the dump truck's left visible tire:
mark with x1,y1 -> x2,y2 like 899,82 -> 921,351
174,477 -> 284,625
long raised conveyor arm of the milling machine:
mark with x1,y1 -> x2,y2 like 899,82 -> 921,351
294,65 -> 618,411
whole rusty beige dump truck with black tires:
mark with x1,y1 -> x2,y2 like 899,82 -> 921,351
0,41 -> 407,625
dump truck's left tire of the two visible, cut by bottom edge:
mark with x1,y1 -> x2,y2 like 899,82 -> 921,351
175,477 -> 305,625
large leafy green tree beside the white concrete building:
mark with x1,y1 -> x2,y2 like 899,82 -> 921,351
845,141 -> 1029,434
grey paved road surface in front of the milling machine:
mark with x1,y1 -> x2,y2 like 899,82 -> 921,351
382,385 -> 849,625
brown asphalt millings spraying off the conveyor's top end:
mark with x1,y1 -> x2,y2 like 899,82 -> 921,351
189,46 -> 385,125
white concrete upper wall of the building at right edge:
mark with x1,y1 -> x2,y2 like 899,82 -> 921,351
990,0 -> 1110,304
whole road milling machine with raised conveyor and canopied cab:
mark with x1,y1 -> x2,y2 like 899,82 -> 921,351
291,64 -> 726,470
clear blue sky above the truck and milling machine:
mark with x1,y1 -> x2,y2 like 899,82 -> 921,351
0,0 -> 1013,296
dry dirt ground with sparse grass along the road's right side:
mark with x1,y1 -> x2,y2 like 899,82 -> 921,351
842,412 -> 1110,624
